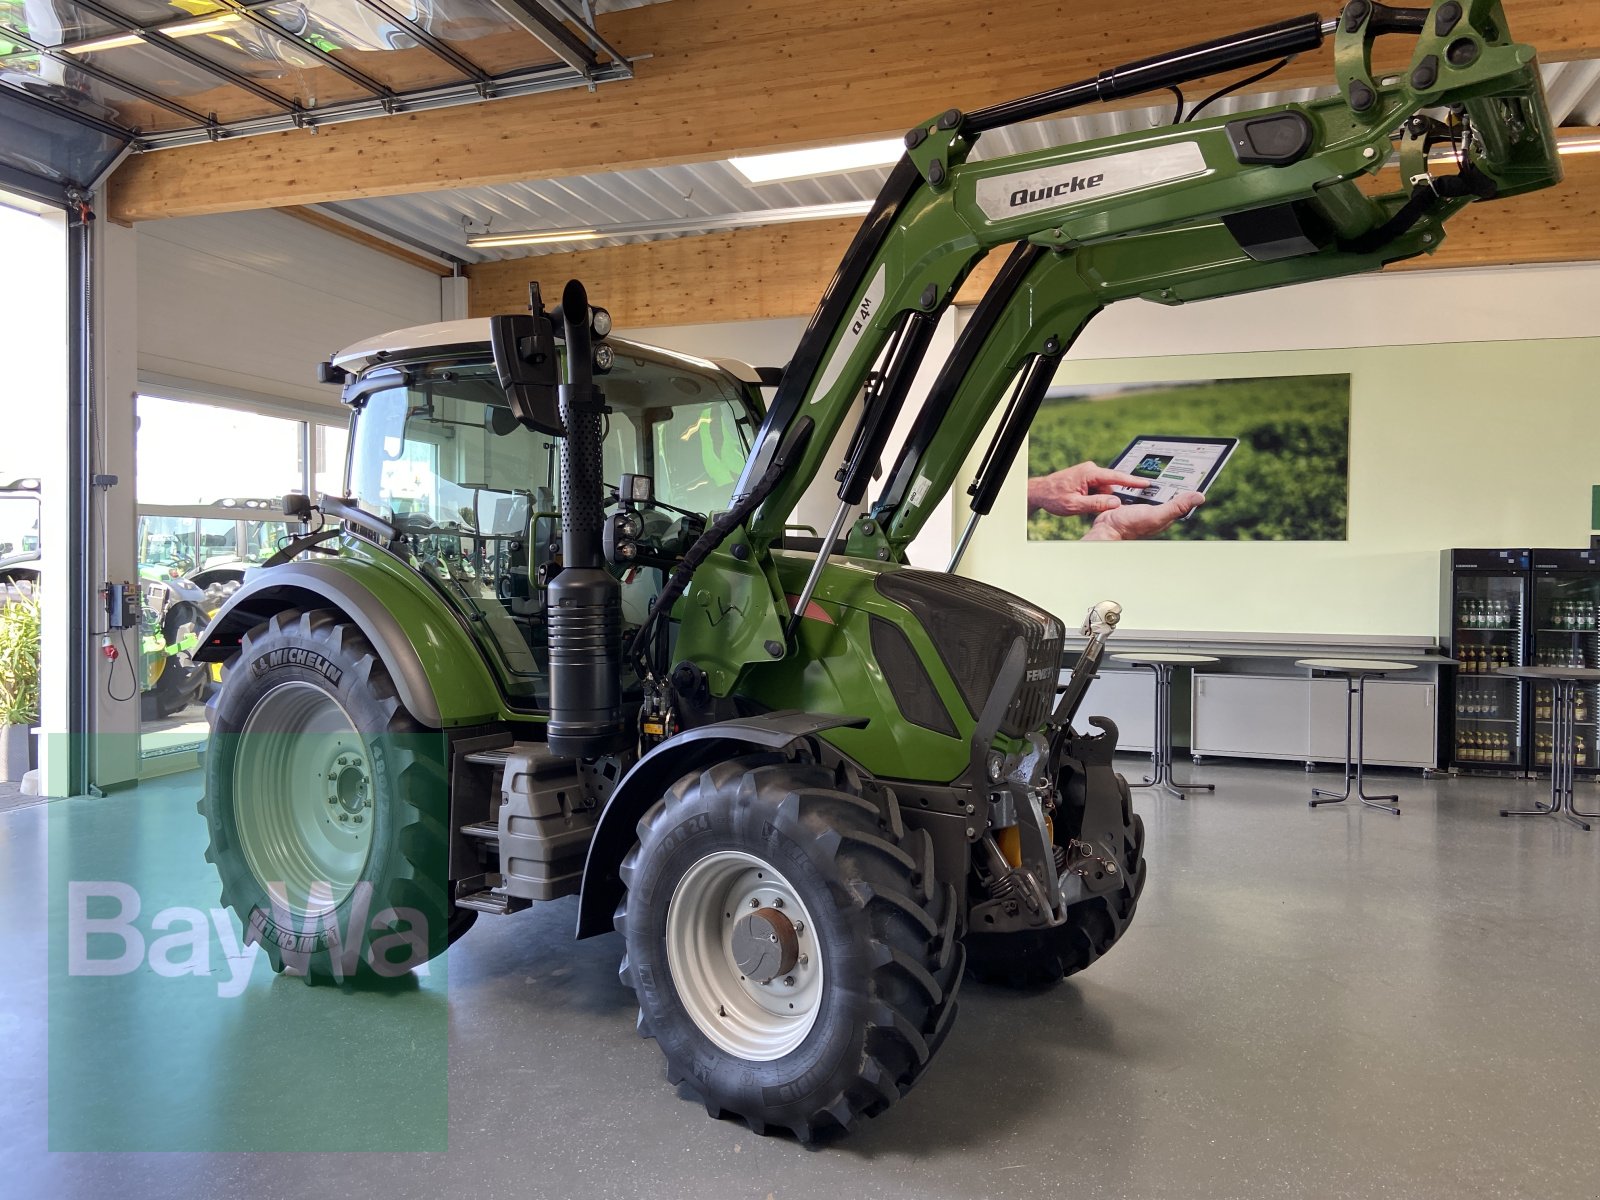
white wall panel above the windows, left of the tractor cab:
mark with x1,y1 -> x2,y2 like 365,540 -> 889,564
138,211 -> 442,406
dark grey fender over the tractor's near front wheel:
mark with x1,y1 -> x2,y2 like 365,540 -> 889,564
578,710 -> 867,938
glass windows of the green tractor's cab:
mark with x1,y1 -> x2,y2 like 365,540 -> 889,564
349,349 -> 752,702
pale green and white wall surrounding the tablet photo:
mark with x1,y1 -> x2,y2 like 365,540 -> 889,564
963,266 -> 1600,637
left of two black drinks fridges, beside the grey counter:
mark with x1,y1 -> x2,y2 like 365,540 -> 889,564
1440,550 -> 1533,773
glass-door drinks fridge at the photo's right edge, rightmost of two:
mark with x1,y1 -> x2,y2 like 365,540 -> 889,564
1528,549 -> 1600,773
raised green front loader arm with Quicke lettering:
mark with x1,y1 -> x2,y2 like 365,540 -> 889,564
738,0 -> 1560,563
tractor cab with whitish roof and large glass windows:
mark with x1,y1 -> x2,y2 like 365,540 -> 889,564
333,320 -> 763,707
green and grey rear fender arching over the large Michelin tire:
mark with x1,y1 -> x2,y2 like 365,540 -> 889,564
194,562 -> 499,730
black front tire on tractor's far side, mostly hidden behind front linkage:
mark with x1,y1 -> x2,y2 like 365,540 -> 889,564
966,774 -> 1147,987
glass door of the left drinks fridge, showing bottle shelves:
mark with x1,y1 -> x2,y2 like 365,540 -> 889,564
1451,571 -> 1526,770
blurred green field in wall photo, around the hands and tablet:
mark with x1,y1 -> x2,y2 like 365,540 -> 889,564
1027,374 -> 1350,542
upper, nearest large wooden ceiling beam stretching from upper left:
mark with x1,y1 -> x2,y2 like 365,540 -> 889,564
109,0 -> 1600,221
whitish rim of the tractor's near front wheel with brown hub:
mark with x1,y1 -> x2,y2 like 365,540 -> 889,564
667,850 -> 822,1062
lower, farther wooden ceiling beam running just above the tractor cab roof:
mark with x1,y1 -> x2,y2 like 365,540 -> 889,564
467,154 -> 1600,330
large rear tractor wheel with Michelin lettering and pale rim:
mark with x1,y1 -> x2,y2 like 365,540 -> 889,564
198,608 -> 475,979
